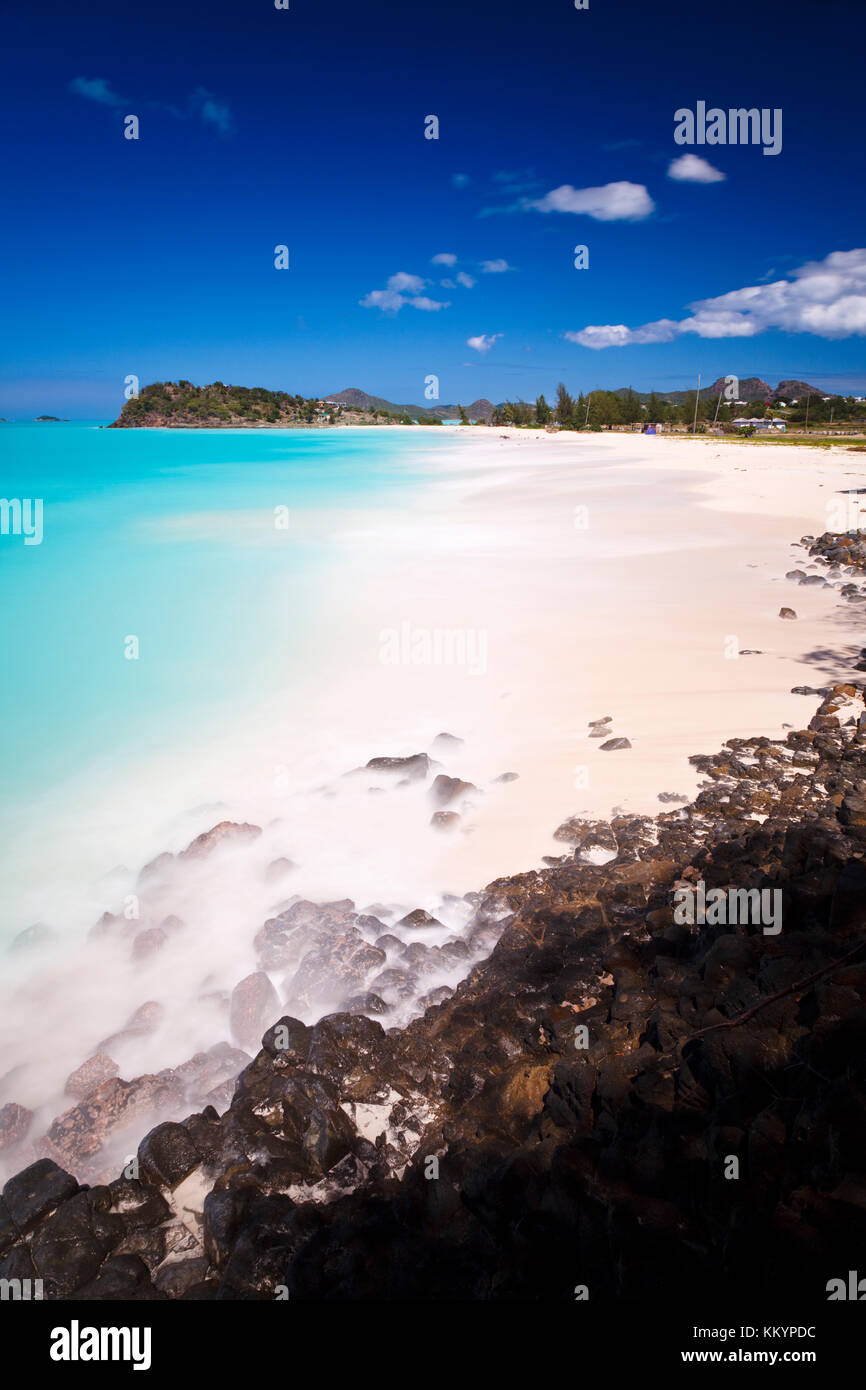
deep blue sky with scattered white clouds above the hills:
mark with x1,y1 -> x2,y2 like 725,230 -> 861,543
0,0 -> 866,418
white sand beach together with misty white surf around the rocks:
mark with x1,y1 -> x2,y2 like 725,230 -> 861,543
4,428 -> 865,1156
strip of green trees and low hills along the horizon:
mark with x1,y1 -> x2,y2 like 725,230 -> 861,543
108,378 -> 866,442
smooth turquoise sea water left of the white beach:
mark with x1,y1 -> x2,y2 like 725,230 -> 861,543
0,423 -> 448,820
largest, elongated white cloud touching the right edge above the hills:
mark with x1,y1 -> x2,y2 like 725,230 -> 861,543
563,247 -> 866,348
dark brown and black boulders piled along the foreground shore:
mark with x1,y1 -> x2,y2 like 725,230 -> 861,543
0,532 -> 866,1301
